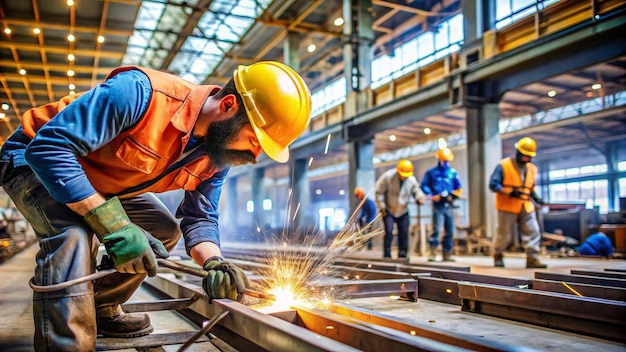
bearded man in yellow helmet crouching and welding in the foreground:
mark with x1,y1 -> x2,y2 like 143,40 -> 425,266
0,61 -> 311,351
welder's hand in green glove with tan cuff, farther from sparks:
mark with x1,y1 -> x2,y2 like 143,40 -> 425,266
84,197 -> 169,276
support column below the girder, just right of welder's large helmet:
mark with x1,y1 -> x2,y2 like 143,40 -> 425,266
287,158 -> 316,237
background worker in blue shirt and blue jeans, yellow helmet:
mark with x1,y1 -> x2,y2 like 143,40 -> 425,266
421,148 -> 462,262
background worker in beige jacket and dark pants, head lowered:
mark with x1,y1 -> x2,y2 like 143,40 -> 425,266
376,159 -> 426,258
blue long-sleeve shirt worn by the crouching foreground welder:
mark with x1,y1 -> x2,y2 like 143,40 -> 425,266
0,70 -> 229,250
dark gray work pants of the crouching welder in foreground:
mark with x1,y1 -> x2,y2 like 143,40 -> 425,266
0,163 -> 181,351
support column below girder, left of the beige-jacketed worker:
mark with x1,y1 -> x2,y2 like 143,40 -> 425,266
348,138 -> 376,214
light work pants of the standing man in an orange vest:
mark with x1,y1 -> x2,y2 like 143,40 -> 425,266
494,208 -> 541,259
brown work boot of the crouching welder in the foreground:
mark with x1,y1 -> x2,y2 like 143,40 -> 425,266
96,306 -> 154,338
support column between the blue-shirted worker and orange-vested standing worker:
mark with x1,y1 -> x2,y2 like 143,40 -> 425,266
464,104 -> 502,237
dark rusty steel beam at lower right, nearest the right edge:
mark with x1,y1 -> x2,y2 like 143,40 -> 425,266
457,282 -> 626,341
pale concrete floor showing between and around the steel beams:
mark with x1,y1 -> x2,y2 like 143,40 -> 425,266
0,244 -> 626,352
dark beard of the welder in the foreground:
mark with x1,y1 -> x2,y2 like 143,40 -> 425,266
204,114 -> 256,169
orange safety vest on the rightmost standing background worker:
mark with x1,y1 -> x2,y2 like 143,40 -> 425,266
496,158 -> 537,214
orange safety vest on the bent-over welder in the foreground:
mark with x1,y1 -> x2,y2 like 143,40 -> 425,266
22,66 -> 220,196
